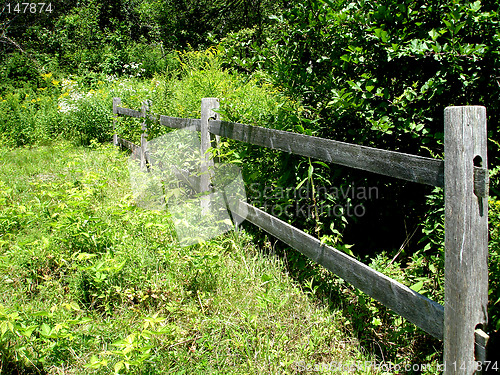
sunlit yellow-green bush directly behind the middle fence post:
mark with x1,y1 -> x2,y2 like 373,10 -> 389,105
146,48 -> 300,128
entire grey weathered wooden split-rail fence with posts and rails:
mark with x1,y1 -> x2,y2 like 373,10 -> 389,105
113,98 -> 489,374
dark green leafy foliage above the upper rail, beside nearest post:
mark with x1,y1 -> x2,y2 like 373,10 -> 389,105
240,0 -> 500,156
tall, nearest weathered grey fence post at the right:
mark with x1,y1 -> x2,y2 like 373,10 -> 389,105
444,106 -> 488,374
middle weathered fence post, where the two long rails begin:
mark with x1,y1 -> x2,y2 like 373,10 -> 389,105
200,98 -> 219,213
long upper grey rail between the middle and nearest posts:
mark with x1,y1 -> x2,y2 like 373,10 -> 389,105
210,121 -> 444,186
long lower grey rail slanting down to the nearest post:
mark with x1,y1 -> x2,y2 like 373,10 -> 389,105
231,201 -> 444,339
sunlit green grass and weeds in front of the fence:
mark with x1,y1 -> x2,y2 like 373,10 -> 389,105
0,143 -> 382,374
